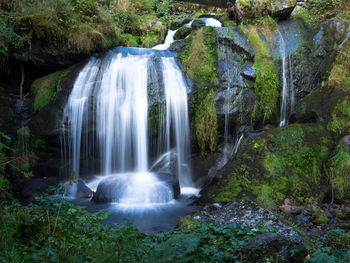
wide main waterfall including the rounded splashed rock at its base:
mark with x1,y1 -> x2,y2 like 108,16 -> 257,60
62,47 -> 193,205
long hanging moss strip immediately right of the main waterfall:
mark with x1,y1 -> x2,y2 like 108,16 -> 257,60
180,27 -> 218,156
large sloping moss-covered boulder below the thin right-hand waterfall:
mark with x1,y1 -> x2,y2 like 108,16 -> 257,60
203,124 -> 332,206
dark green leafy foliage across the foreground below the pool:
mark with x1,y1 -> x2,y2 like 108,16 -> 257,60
0,196 -> 274,262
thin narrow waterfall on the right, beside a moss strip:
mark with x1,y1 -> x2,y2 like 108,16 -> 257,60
277,29 -> 295,127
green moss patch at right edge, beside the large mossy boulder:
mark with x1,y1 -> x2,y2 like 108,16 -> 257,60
328,142 -> 350,202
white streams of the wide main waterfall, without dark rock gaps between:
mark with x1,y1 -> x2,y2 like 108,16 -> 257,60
63,48 -> 192,205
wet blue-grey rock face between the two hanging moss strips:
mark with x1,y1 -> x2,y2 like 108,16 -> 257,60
215,28 -> 256,128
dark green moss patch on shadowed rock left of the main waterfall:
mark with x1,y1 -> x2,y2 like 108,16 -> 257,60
32,69 -> 69,111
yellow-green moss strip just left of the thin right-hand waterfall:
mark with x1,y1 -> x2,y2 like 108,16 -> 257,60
240,26 -> 278,122
